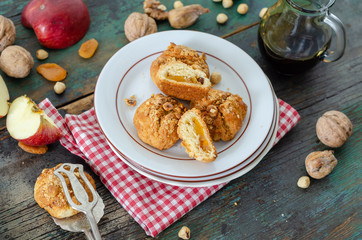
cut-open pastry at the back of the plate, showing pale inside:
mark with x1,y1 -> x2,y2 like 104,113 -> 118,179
150,43 -> 212,100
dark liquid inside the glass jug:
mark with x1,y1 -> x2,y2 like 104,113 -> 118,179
258,13 -> 330,75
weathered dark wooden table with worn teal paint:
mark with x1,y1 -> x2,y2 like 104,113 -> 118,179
0,0 -> 362,239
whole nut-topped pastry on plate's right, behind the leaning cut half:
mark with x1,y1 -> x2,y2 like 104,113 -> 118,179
190,89 -> 248,141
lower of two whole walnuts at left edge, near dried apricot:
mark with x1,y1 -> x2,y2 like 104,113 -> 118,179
0,45 -> 34,78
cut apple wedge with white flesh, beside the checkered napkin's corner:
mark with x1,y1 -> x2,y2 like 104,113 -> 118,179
6,96 -> 62,146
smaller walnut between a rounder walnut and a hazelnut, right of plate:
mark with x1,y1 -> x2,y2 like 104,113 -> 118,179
305,150 -> 338,179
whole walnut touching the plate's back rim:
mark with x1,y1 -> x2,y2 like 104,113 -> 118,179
124,12 -> 157,42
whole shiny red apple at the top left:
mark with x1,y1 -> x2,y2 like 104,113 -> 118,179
21,0 -> 90,49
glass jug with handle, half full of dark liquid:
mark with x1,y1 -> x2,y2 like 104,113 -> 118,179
258,0 -> 345,75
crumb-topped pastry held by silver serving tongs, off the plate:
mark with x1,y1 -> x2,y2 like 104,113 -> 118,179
34,164 -> 96,218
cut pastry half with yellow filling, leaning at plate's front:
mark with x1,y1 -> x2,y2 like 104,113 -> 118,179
177,108 -> 217,162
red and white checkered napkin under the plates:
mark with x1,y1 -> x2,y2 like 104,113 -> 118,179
39,99 -> 300,237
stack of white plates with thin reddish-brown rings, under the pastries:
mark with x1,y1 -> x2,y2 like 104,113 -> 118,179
94,30 -> 279,187
